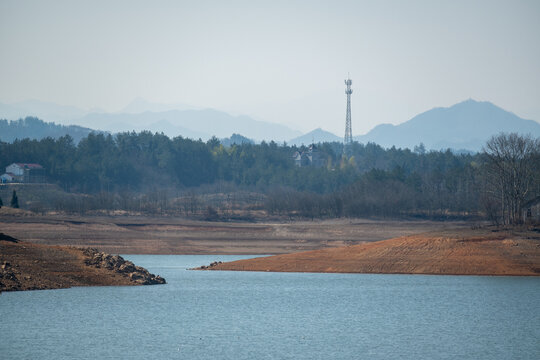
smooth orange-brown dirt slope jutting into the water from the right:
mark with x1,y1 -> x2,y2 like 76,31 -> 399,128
198,231 -> 540,276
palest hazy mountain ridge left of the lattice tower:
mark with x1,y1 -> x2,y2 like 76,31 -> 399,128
0,99 -> 301,141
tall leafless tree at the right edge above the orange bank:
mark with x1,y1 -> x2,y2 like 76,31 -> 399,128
483,133 -> 540,224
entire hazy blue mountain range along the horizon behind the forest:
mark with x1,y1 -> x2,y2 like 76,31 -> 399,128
0,99 -> 540,151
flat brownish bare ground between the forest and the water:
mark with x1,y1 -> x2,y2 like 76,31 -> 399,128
0,208 -> 471,254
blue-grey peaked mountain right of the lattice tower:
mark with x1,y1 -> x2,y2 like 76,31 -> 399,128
354,99 -> 540,151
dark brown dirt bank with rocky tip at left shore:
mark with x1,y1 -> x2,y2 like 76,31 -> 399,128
0,234 -> 165,292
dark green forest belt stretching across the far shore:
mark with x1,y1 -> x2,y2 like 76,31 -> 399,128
0,132 -> 540,222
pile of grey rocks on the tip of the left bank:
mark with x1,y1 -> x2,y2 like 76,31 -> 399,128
83,248 -> 165,285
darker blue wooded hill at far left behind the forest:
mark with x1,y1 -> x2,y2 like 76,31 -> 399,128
0,117 -> 99,143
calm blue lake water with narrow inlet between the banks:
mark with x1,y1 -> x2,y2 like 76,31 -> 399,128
0,255 -> 540,360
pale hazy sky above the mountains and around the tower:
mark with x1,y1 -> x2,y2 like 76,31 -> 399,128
0,0 -> 540,136
